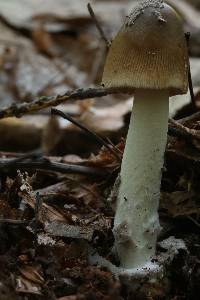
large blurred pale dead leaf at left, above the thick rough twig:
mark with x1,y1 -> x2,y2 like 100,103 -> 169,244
0,23 -> 69,105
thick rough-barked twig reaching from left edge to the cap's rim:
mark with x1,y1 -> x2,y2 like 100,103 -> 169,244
0,88 -> 113,119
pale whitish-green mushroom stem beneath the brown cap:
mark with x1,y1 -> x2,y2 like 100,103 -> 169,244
114,90 -> 169,268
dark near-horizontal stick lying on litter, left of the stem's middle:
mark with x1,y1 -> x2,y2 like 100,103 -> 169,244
0,159 -> 108,177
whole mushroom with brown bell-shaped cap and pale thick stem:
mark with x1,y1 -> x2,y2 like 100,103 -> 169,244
102,0 -> 188,269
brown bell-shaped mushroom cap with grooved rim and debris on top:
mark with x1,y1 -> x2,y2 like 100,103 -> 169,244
102,0 -> 189,95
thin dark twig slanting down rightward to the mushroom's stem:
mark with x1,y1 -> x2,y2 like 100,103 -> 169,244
51,108 -> 121,161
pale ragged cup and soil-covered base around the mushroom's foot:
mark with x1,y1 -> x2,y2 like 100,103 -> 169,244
88,236 -> 188,300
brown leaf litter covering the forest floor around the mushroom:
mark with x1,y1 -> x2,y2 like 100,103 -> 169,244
0,0 -> 200,300
